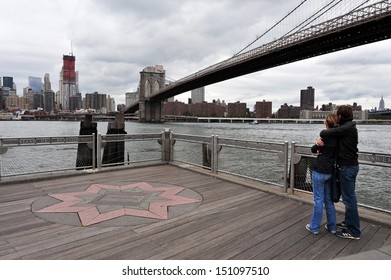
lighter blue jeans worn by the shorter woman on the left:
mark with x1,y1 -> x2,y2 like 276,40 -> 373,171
310,171 -> 337,232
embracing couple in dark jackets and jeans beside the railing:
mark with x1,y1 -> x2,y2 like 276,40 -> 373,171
306,105 -> 361,240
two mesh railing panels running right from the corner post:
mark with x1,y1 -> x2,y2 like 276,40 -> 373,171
173,134 -> 288,191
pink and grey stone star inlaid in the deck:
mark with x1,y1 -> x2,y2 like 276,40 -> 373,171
37,182 -> 200,226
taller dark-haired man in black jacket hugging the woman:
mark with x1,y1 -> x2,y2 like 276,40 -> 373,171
318,105 -> 361,240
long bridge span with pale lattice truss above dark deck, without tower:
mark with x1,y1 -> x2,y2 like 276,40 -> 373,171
124,1 -> 391,113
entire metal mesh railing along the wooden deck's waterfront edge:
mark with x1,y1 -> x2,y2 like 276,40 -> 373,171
0,129 -> 391,213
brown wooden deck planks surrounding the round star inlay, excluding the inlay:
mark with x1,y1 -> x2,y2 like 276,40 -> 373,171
0,165 -> 391,260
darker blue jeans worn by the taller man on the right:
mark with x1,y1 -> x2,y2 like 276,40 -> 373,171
339,165 -> 361,236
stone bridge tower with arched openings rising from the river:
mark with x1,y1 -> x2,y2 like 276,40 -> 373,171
139,65 -> 166,123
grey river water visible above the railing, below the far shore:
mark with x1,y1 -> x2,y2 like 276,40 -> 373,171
0,121 -> 391,153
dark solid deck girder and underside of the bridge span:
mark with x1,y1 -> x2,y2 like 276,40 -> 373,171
125,14 -> 391,113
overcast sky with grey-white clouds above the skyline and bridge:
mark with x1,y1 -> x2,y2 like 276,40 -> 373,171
0,0 -> 391,114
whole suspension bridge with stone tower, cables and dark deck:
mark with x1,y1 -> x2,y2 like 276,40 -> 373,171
123,0 -> 391,122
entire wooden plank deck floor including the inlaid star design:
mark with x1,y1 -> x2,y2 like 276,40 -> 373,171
0,164 -> 391,260
